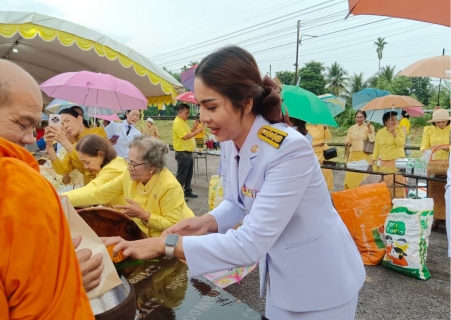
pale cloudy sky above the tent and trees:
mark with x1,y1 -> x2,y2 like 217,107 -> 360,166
0,0 -> 451,85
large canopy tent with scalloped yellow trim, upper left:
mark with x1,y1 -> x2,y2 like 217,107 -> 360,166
0,11 -> 183,107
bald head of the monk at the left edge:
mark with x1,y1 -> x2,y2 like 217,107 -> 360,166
0,59 -> 43,145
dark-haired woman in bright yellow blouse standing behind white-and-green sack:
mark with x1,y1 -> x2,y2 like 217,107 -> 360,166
371,111 -> 406,199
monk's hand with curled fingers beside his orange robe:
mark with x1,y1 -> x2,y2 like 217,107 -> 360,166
72,235 -> 104,292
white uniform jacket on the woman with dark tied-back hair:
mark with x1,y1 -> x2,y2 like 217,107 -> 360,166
183,116 -> 365,312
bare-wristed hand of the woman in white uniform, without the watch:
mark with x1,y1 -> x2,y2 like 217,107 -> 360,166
161,214 -> 218,236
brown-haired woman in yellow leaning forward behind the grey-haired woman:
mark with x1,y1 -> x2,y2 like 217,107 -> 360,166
65,134 -> 127,206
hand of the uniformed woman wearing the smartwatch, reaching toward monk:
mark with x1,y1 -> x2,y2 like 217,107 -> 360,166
100,237 -> 165,260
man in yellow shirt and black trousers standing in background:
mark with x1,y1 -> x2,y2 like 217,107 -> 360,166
172,103 -> 203,198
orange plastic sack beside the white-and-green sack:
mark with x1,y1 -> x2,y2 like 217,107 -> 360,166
331,183 -> 392,266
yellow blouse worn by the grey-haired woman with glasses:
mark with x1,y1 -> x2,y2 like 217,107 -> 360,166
68,168 -> 194,237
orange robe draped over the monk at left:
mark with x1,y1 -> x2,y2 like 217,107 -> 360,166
0,138 -> 94,320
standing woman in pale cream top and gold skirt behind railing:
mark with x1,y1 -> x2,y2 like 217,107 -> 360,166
344,110 -> 376,189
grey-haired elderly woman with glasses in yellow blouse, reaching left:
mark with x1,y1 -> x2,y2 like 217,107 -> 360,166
67,135 -> 194,237
